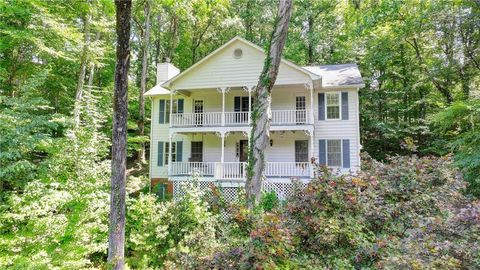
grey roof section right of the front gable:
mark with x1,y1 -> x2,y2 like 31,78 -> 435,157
303,64 -> 365,88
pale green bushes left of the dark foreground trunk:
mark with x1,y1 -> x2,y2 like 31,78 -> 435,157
0,129 -> 110,269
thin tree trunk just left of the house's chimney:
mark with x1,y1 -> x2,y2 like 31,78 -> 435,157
137,1 -> 150,164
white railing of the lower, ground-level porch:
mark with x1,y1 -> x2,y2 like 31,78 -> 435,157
170,162 -> 312,180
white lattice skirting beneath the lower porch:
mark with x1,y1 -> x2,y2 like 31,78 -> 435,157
173,180 -> 306,202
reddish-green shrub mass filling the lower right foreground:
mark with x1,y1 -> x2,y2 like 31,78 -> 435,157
201,156 -> 480,269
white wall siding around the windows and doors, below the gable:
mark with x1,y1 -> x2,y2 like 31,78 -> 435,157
151,87 -> 360,178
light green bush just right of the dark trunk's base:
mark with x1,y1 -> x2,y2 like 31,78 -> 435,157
127,178 -> 219,269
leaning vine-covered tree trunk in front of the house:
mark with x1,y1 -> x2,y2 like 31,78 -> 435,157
246,0 -> 292,209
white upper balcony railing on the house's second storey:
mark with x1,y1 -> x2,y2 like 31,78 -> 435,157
170,110 -> 311,127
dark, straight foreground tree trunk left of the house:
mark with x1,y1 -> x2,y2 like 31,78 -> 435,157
108,0 -> 132,269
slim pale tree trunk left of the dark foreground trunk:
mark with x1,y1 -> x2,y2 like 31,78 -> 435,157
73,8 -> 91,128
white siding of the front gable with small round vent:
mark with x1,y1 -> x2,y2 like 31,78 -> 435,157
172,40 -> 311,89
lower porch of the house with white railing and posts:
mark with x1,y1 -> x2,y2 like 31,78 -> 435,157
166,130 -> 314,181
